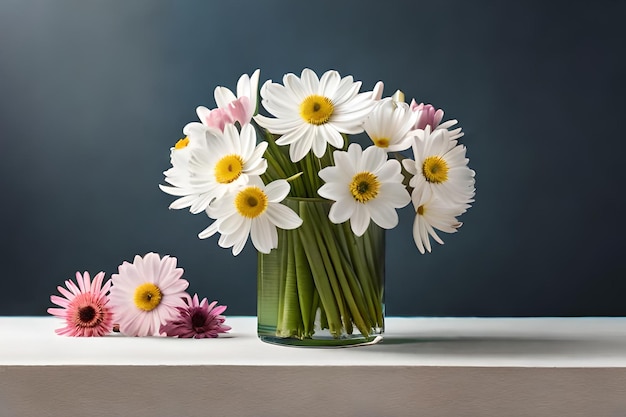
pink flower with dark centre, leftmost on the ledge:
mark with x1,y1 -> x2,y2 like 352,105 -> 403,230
48,272 -> 113,337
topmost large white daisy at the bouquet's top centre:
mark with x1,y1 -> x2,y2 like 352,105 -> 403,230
254,68 -> 377,162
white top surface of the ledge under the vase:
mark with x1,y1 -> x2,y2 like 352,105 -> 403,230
0,317 -> 626,367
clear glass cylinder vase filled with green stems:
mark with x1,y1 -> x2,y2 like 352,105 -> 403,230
257,198 -> 385,347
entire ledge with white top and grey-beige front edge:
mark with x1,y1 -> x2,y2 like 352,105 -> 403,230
0,317 -> 626,417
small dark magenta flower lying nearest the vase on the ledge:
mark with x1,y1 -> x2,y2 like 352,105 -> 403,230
160,294 -> 231,339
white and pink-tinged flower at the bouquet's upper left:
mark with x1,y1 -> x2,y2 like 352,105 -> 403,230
183,69 -> 260,134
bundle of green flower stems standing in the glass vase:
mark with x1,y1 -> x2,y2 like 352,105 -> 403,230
258,123 -> 385,339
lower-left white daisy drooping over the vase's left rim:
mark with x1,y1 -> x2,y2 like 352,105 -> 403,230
198,178 -> 302,256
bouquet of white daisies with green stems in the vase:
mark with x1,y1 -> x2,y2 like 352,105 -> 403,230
160,69 -> 475,339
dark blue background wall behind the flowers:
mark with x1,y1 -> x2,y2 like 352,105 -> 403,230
0,0 -> 626,316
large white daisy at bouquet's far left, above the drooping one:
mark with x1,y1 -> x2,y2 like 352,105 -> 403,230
159,124 -> 267,214
